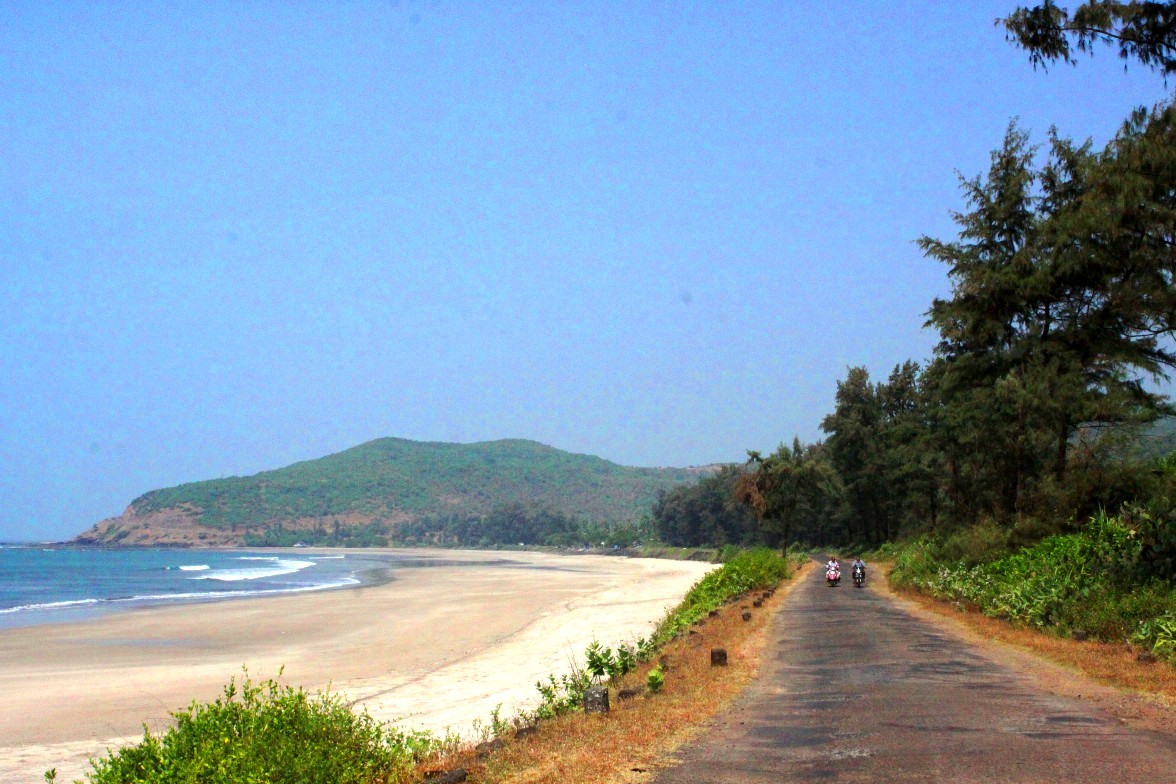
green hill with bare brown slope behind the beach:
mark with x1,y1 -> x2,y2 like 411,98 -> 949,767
76,438 -> 706,544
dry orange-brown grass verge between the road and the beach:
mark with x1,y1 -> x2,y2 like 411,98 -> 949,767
421,568 -> 807,784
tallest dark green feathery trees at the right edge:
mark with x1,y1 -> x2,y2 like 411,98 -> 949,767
920,118 -> 1176,521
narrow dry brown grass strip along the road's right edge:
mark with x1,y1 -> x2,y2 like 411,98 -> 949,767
882,564 -> 1176,704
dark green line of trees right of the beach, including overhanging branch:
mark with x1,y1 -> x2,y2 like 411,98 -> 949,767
654,1 -> 1176,561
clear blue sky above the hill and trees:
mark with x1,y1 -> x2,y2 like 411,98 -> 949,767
0,0 -> 1168,540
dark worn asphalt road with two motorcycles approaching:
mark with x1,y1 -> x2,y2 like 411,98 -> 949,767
655,570 -> 1176,784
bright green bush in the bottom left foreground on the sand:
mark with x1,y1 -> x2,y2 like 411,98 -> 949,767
75,676 -> 437,784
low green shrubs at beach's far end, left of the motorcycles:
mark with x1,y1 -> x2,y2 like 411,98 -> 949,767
653,548 -> 791,646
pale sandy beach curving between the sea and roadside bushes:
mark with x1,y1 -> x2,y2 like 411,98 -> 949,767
0,550 -> 710,783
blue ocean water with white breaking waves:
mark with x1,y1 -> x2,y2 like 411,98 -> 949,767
0,544 -> 409,629
